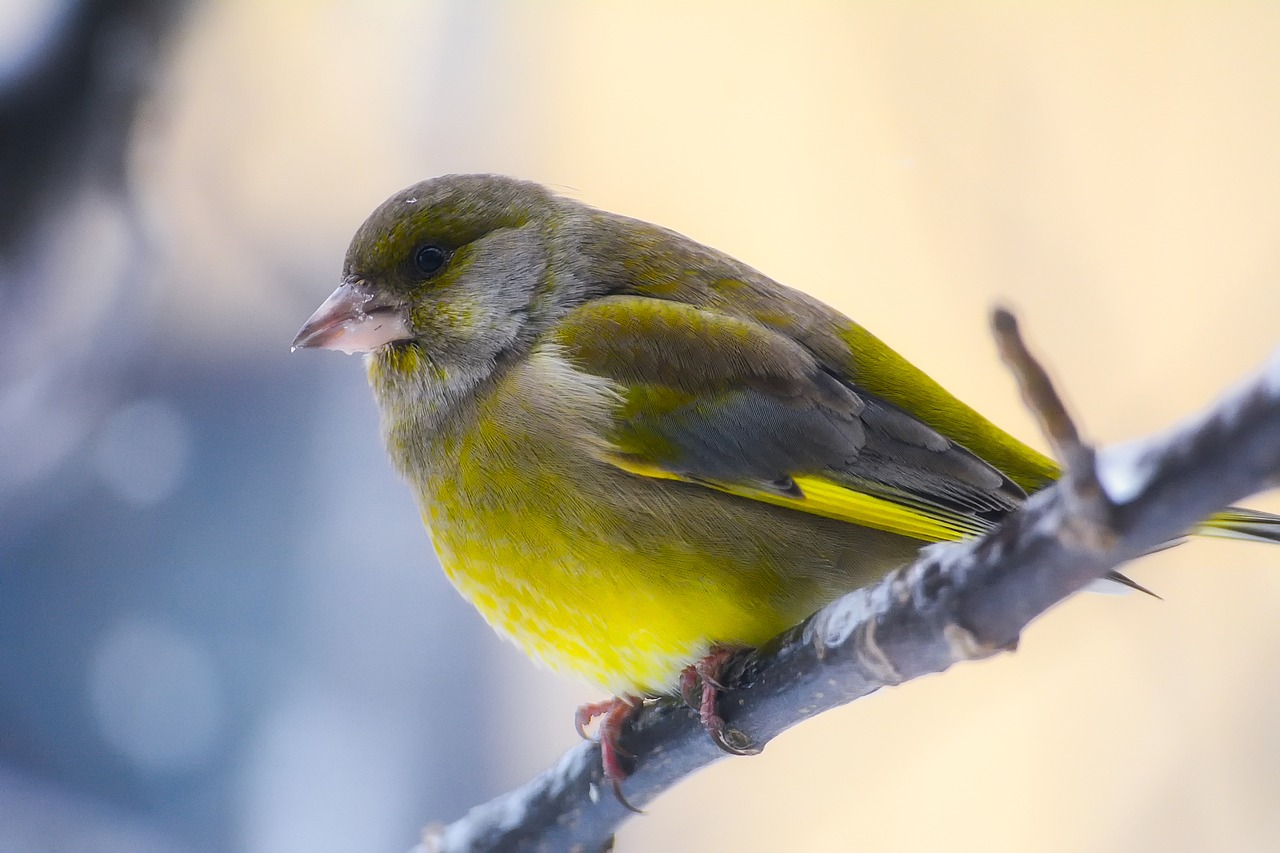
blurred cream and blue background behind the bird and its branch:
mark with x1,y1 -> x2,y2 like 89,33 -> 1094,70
0,0 -> 1280,853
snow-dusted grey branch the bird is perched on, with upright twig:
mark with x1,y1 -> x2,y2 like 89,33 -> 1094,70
422,311 -> 1280,853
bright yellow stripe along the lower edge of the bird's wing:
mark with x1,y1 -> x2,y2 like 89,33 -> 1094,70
605,453 -> 991,542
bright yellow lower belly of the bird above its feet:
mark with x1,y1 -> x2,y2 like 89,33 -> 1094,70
428,481 -> 792,694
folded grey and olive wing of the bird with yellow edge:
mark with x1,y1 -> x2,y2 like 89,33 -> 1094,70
550,296 -> 1025,540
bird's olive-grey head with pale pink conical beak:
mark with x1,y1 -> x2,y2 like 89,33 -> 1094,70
293,175 -> 563,369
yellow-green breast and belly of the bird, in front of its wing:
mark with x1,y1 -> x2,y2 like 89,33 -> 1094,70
421,351 -> 795,693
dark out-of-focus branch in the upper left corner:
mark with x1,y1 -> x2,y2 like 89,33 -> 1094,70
0,0 -> 187,257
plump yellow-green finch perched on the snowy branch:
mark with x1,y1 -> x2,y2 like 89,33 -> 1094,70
293,174 -> 1280,804
